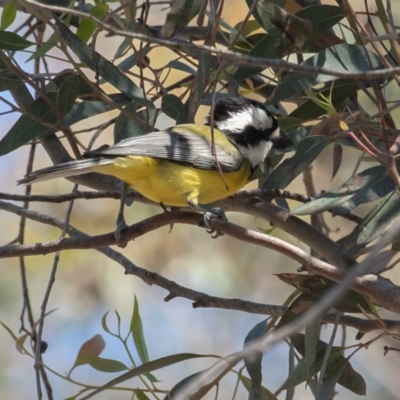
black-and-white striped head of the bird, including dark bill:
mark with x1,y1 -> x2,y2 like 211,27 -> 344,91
206,97 -> 293,168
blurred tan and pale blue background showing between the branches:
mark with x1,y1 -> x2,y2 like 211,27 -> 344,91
0,0 -> 400,400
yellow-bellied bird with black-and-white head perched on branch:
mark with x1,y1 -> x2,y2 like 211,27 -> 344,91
18,97 -> 293,244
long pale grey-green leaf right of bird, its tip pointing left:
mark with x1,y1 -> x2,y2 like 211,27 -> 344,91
292,165 -> 395,215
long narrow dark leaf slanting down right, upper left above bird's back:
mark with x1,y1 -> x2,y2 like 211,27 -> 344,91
55,17 -> 149,106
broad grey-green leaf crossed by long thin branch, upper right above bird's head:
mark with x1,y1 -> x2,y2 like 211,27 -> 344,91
268,43 -> 383,104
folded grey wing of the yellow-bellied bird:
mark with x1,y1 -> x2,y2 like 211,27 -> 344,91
84,131 -> 243,172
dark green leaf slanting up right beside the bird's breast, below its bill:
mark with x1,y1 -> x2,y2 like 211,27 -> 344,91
263,136 -> 331,189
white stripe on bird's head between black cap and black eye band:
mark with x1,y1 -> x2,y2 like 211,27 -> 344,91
217,106 -> 272,133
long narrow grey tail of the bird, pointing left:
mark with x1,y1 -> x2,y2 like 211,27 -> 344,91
17,157 -> 114,185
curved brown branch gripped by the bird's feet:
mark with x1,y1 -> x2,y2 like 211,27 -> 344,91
0,202 -> 400,313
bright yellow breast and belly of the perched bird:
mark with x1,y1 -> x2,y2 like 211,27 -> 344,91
93,156 -> 250,207
